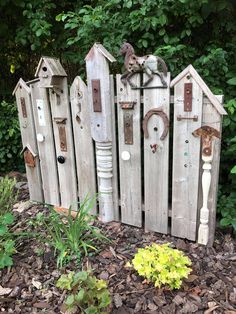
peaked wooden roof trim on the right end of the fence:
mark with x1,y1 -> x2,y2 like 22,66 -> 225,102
170,64 -> 227,115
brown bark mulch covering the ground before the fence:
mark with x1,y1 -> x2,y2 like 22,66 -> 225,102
0,173 -> 236,314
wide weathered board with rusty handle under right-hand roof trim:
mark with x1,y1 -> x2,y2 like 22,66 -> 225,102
171,75 -> 203,241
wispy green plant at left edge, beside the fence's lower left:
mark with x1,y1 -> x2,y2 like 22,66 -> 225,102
0,176 -> 17,213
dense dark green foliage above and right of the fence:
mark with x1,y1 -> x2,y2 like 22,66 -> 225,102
0,0 -> 236,225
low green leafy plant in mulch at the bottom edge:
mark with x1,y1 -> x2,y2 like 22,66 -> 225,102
57,271 -> 111,314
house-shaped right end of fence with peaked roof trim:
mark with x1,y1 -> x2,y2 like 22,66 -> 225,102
171,65 -> 227,244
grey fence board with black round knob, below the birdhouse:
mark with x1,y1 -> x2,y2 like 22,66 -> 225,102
49,77 -> 78,209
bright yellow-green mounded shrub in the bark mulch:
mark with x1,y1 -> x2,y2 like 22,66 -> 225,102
132,243 -> 191,289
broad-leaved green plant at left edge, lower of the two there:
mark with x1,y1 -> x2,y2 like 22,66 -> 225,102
0,213 -> 16,269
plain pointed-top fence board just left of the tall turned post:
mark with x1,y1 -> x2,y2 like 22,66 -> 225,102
70,76 -> 97,214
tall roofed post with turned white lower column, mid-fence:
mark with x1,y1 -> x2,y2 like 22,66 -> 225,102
85,44 -> 118,222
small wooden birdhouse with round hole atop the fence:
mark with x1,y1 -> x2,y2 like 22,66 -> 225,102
35,57 -> 67,88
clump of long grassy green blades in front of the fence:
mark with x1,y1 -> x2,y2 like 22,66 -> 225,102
36,199 -> 108,267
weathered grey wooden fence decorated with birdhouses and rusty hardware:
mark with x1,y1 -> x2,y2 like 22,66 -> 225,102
14,44 -> 226,245
